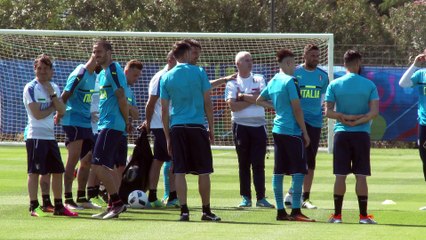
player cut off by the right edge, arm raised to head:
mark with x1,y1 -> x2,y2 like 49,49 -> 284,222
399,49 -> 426,210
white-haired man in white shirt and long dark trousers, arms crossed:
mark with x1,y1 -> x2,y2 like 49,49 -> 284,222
225,51 -> 274,208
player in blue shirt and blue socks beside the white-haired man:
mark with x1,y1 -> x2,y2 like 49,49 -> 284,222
256,49 -> 315,222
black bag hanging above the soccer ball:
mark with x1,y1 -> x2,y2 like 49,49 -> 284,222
118,128 -> 154,203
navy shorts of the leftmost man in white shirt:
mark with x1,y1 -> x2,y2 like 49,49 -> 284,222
25,139 -> 65,175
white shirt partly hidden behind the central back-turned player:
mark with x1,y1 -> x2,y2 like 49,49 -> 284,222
148,65 -> 171,129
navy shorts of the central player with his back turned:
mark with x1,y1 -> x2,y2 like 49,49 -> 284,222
170,124 -> 213,175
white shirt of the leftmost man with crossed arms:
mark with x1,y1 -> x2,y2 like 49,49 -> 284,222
23,79 -> 61,140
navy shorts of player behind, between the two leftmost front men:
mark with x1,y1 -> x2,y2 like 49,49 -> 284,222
62,126 -> 95,159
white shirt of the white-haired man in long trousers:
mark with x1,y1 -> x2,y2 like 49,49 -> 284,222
225,73 -> 266,127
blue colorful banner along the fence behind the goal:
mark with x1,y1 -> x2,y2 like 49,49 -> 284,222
0,60 -> 418,141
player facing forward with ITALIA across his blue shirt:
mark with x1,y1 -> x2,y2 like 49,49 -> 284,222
284,44 -> 328,209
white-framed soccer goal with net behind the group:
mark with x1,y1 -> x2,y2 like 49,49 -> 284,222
0,29 -> 334,148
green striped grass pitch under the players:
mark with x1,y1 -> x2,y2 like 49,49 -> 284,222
0,147 -> 426,240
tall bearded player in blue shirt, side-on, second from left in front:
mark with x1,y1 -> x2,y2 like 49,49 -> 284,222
92,40 -> 130,219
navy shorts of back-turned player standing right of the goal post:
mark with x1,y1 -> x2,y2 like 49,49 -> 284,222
333,132 -> 371,176
